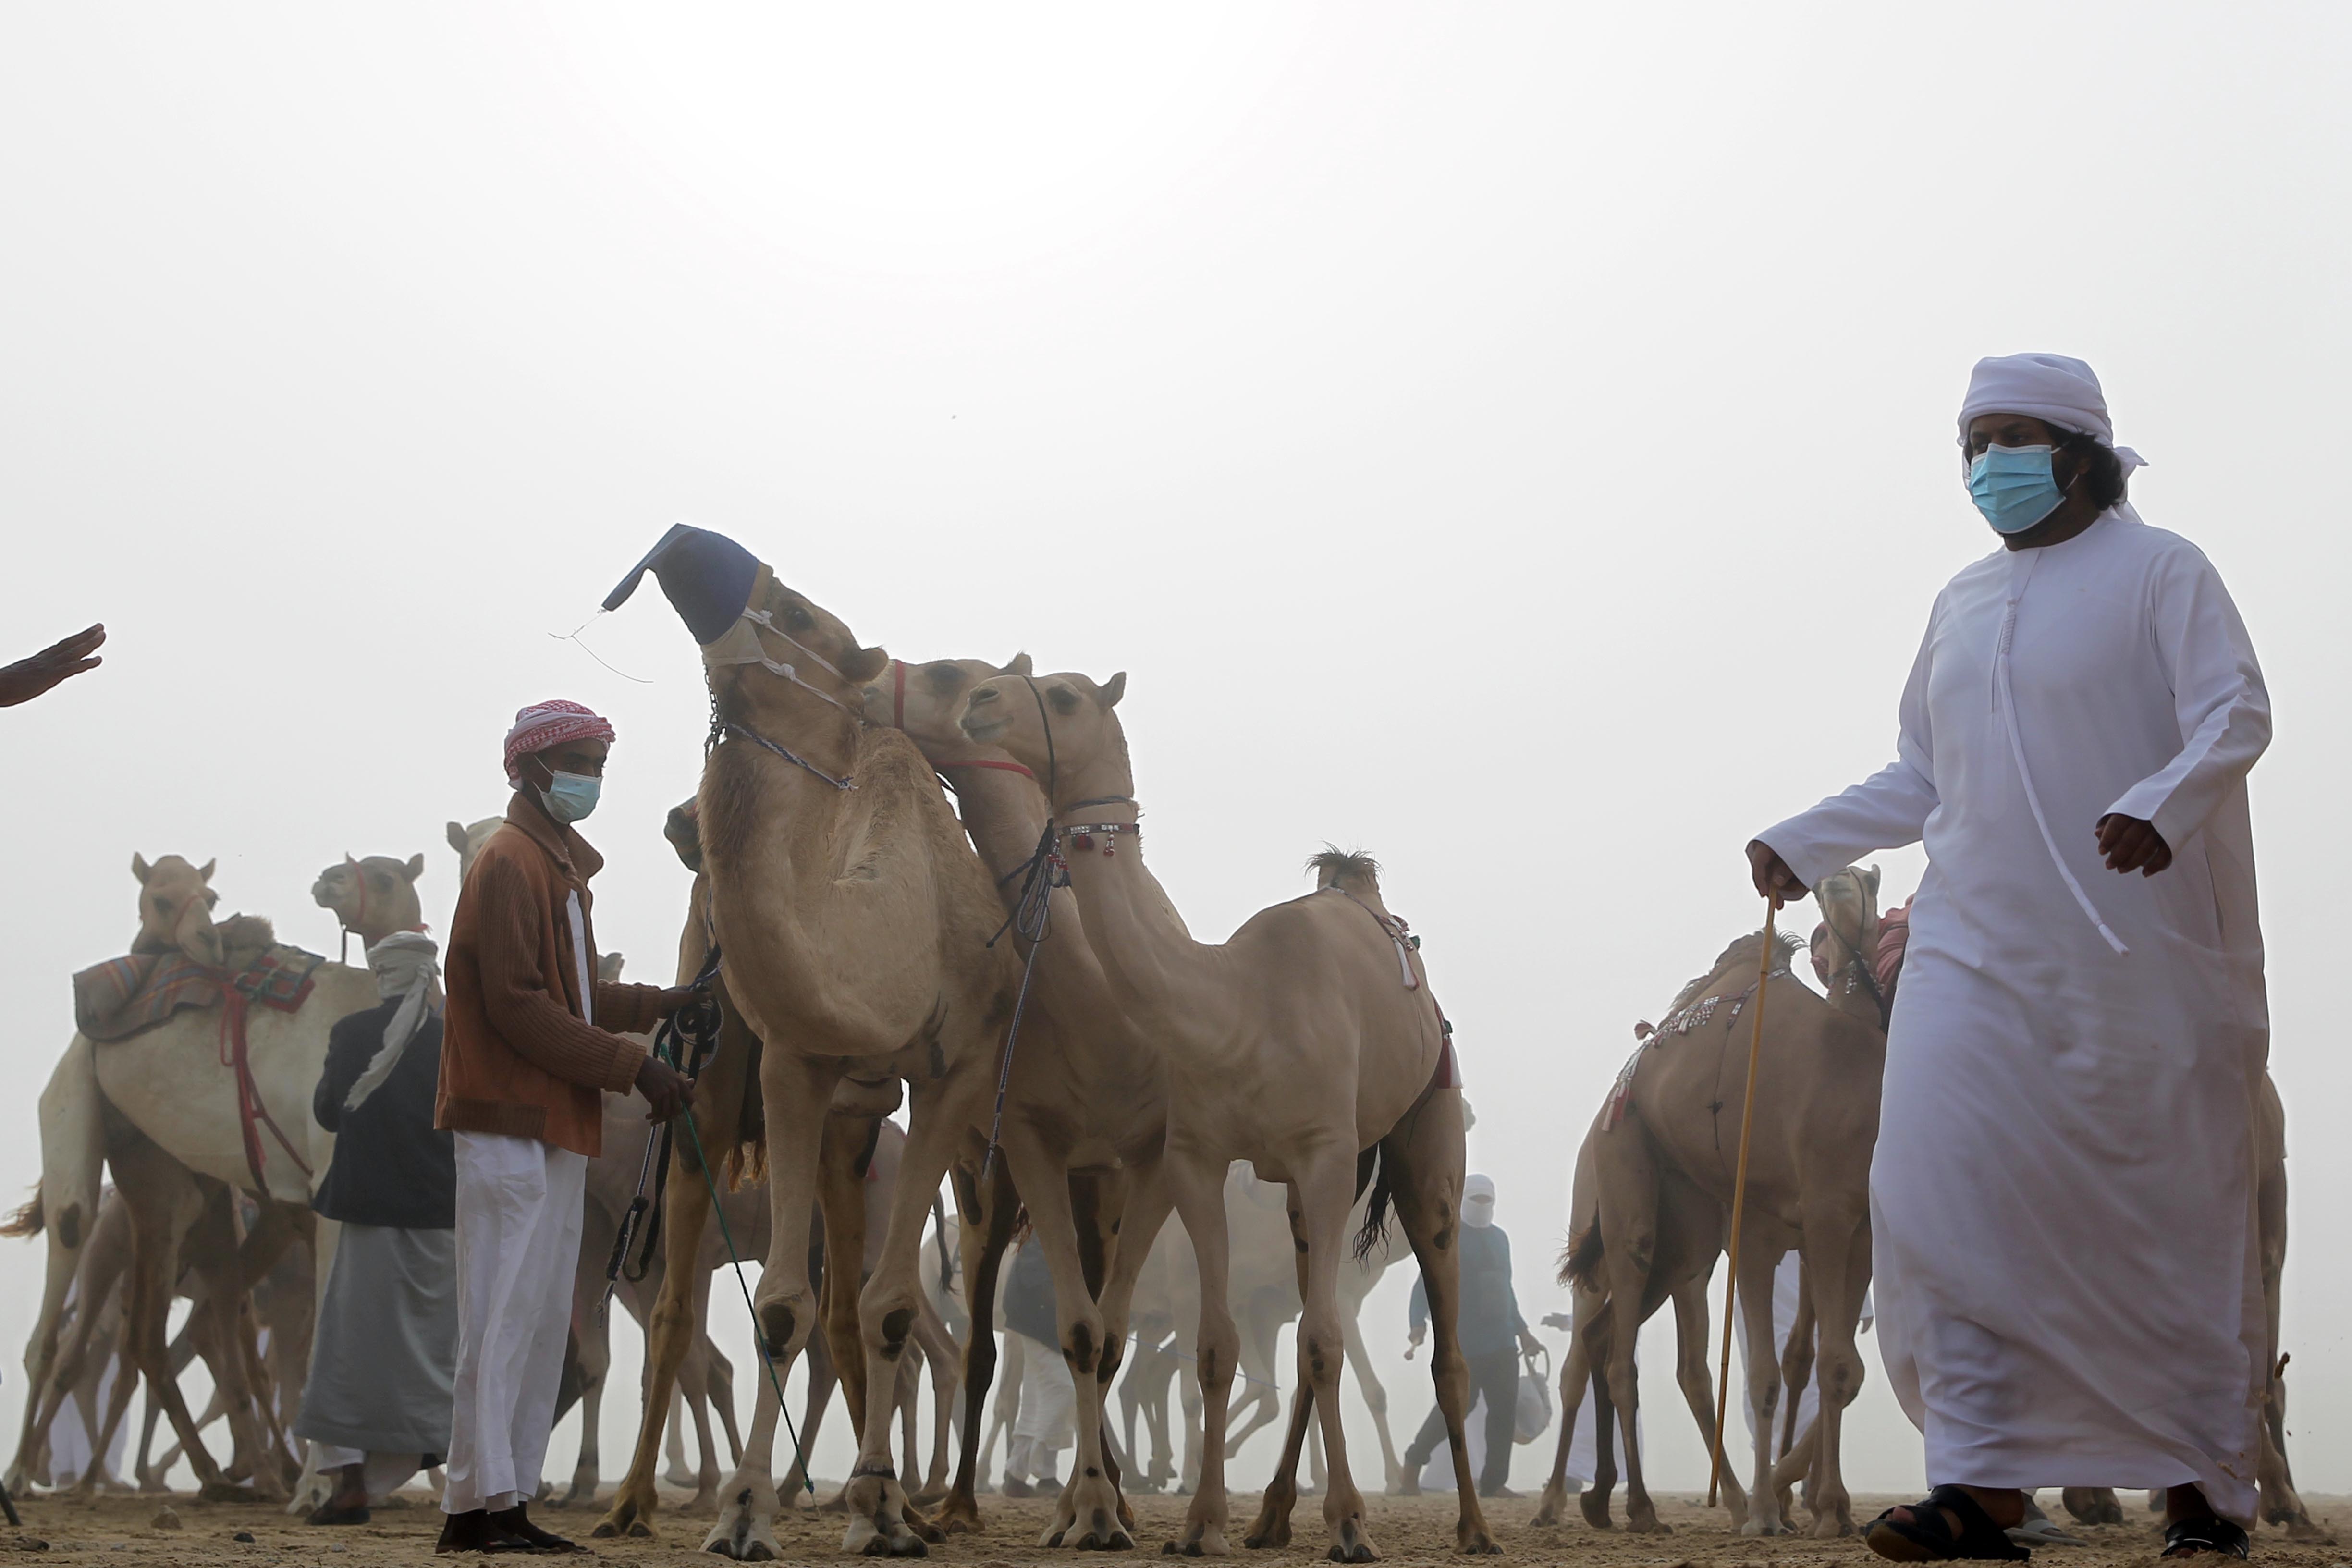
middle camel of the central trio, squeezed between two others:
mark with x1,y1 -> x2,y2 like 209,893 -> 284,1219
863,653 -> 1176,1552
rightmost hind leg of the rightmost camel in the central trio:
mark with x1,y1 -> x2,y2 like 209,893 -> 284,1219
1373,1089 -> 1503,1556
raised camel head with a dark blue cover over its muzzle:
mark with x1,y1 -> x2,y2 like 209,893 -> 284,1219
604,524 -> 889,731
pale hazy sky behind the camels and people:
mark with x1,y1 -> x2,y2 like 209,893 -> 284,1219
0,2 -> 2352,1491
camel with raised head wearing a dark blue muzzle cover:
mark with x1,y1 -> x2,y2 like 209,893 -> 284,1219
600,527 -> 1018,1554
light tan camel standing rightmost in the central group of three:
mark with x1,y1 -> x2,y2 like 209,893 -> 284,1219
960,673 -> 1498,1561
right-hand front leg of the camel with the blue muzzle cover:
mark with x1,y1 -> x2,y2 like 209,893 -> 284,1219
842,1100 -> 969,1556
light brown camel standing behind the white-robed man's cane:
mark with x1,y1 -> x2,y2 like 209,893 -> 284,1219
1564,868 -> 1886,1535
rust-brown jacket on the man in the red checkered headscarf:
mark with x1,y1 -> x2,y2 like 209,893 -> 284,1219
433,792 -> 661,1159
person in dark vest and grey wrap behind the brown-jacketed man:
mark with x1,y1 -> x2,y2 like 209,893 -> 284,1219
294,931 -> 456,1526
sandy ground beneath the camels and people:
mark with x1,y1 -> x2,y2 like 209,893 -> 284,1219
0,1495 -> 2352,1568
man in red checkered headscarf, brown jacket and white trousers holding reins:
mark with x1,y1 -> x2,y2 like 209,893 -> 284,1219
433,700 -> 691,1552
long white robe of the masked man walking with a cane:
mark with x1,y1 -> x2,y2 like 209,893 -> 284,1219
1759,505 -> 2270,1521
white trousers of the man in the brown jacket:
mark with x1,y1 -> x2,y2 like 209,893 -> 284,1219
442,1133 -> 588,1514
